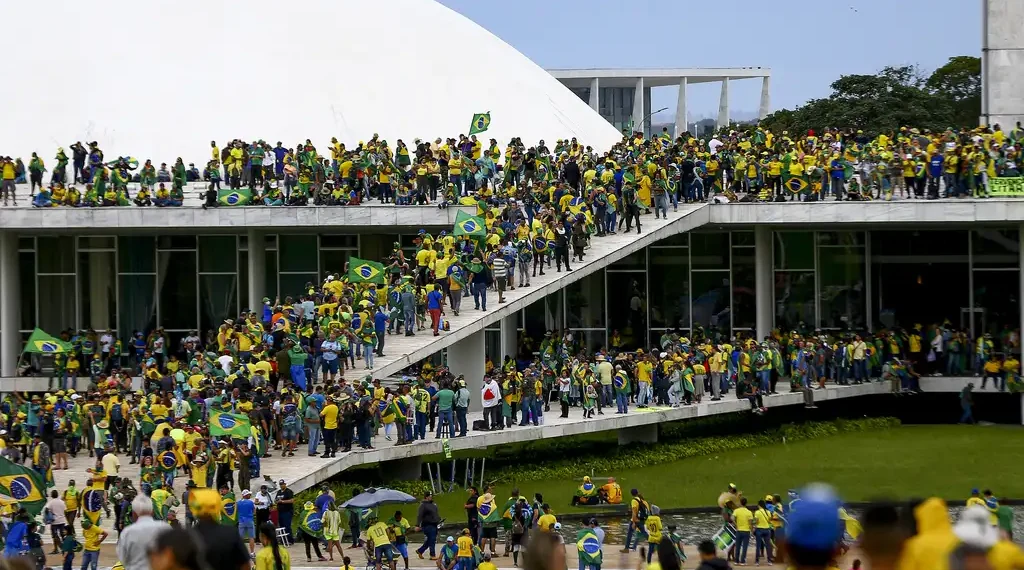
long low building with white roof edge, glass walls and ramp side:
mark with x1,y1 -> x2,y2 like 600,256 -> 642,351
0,201 -> 1024,386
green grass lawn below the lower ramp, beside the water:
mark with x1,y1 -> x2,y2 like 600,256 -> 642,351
435,426 -> 1024,520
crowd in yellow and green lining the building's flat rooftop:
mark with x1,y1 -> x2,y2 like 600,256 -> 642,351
8,124 -> 1024,208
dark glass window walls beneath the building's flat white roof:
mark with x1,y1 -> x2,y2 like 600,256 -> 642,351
8,228 -> 1021,351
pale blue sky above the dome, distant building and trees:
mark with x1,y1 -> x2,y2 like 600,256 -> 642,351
439,0 -> 981,122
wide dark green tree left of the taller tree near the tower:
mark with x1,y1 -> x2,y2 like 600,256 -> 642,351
761,65 -> 977,136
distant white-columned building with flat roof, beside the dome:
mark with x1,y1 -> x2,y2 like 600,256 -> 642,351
548,68 -> 771,135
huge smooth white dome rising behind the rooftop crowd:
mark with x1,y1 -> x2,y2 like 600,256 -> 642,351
0,0 -> 621,169
